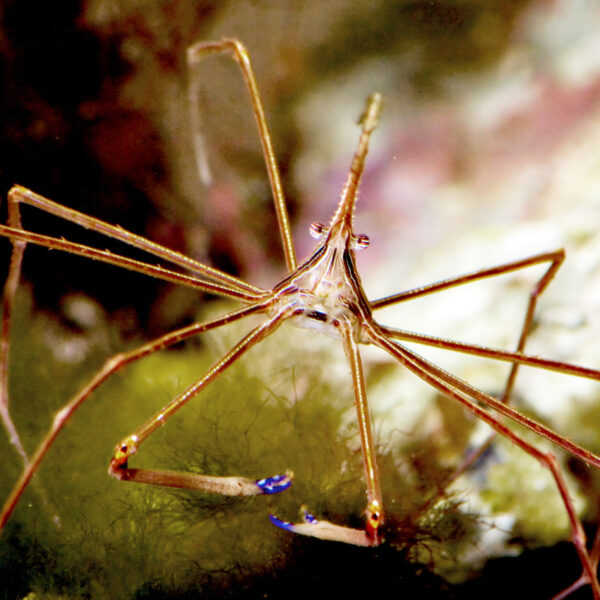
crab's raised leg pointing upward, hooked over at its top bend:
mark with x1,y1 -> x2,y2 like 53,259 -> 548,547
187,39 -> 297,273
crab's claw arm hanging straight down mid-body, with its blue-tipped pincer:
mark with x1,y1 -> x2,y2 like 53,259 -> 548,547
271,320 -> 383,546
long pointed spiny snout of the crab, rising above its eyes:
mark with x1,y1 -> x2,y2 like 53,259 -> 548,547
330,93 -> 381,228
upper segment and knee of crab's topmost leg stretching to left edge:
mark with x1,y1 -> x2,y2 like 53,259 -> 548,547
8,185 -> 263,297
